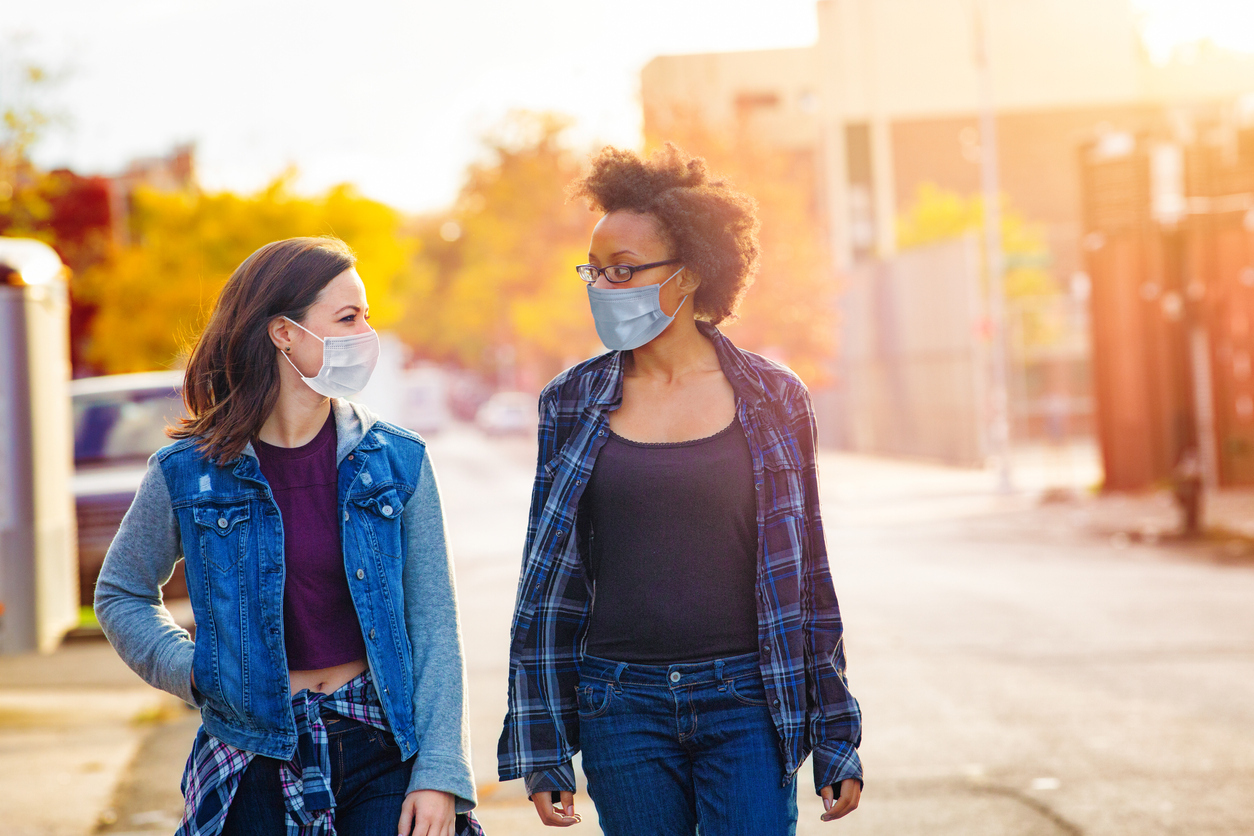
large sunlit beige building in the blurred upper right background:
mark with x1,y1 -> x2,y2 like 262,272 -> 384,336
641,0 -> 1254,277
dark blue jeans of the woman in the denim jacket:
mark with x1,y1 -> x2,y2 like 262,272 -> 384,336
222,712 -> 410,836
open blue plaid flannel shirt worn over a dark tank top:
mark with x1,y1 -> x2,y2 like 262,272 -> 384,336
497,322 -> 861,793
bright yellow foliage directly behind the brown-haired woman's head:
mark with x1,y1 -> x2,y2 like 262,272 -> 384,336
74,172 -> 415,372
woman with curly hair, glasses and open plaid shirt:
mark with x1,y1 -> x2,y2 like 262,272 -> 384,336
499,145 -> 861,836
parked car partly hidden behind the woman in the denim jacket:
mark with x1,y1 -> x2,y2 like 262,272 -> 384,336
70,371 -> 187,605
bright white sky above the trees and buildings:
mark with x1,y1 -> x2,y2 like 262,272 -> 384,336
7,0 -> 1254,212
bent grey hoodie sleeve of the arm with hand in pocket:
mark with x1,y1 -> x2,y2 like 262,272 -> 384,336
95,456 -> 199,706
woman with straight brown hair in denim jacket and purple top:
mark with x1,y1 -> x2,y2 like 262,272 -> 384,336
95,238 -> 482,836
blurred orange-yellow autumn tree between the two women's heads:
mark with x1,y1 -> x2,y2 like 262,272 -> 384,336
398,112 -> 603,389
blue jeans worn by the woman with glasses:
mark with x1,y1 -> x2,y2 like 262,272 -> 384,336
577,654 -> 796,836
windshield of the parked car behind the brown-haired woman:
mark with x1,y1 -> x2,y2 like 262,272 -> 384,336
74,389 -> 184,466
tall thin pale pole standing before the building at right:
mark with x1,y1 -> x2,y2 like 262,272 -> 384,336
974,0 -> 1013,494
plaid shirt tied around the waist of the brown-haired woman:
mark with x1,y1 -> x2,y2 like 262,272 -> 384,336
176,671 -> 483,836
